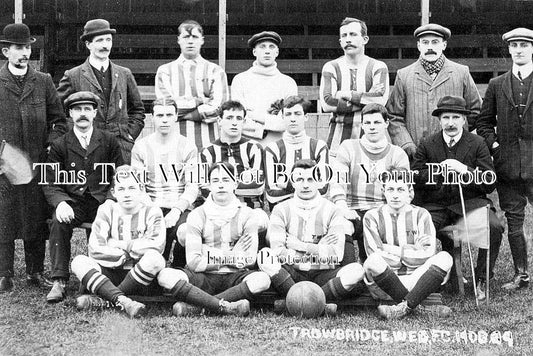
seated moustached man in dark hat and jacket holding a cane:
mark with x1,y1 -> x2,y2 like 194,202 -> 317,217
412,96 -> 503,300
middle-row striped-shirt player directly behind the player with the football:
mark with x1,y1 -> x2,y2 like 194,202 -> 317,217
264,96 -> 329,210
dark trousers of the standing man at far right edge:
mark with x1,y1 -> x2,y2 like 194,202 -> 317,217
496,179 -> 533,278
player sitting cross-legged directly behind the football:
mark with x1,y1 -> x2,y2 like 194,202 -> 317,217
258,159 -> 363,314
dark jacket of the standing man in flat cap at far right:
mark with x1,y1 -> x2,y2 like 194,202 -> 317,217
476,71 -> 533,182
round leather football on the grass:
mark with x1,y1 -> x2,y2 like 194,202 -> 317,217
285,281 -> 326,318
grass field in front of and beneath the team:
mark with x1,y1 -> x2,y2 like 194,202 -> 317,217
0,202 -> 533,356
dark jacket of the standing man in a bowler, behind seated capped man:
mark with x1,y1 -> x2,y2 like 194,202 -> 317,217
57,59 -> 144,144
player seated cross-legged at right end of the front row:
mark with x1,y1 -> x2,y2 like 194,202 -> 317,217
363,169 -> 453,319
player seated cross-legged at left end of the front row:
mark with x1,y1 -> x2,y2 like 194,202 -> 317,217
71,166 -> 165,318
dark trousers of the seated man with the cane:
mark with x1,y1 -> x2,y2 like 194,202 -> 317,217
429,209 -> 504,280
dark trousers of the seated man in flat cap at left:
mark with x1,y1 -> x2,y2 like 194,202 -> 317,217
50,194 -> 100,279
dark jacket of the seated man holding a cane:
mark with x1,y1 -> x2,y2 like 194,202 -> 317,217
411,130 -> 495,214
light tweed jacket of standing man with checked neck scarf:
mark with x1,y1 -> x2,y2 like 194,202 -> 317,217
387,58 -> 481,149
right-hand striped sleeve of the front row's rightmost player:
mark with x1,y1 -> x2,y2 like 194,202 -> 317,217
402,208 -> 437,268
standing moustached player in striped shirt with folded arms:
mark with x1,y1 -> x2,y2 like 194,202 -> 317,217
320,17 -> 389,156
